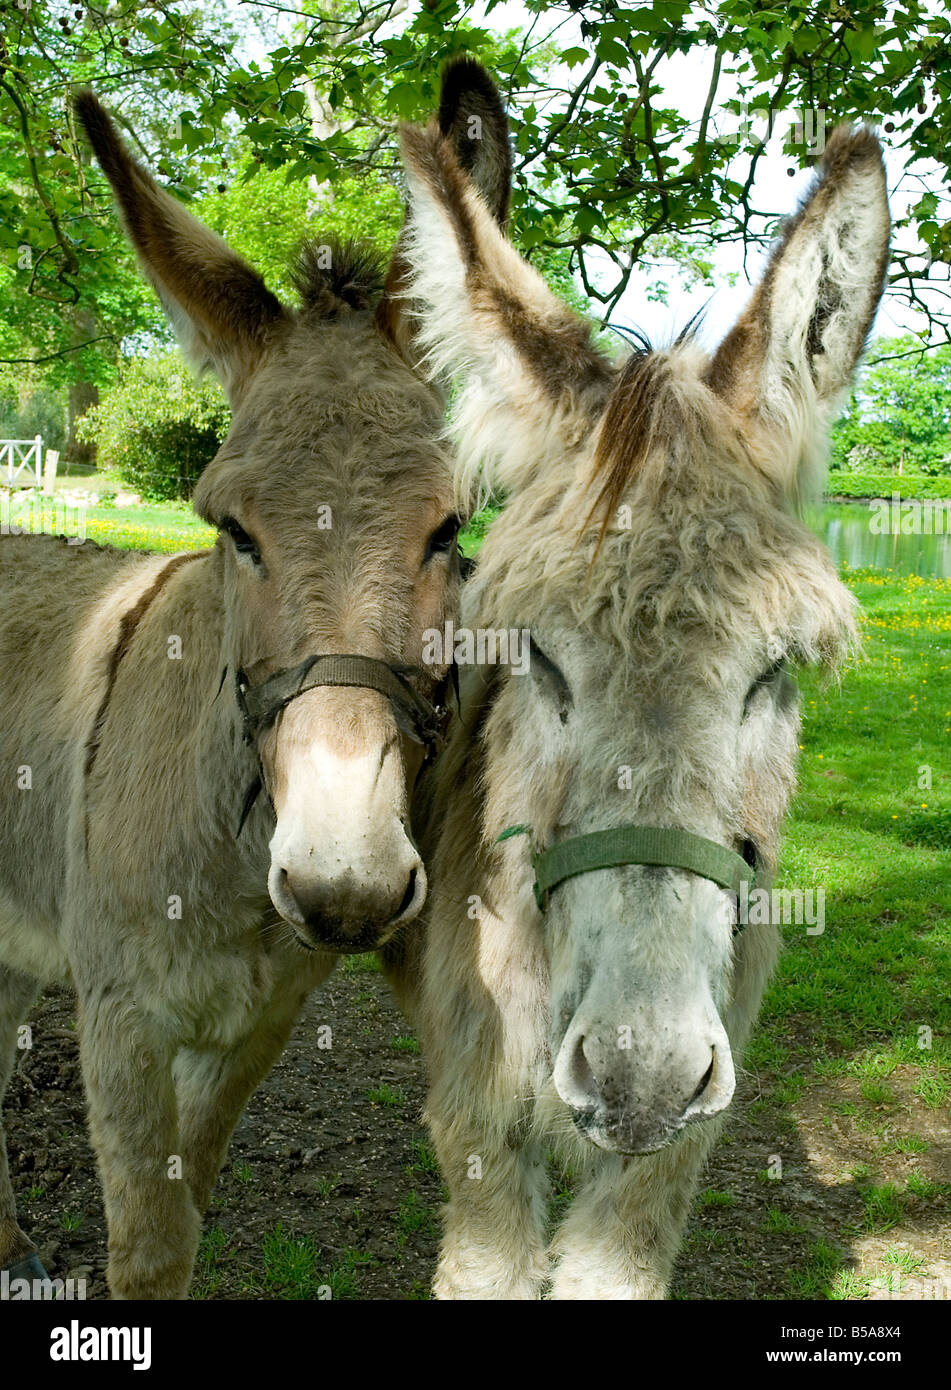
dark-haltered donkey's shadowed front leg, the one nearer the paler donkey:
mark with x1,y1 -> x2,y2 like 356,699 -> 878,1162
175,956 -> 336,1212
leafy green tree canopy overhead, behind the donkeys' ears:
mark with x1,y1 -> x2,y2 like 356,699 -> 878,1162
0,0 -> 951,397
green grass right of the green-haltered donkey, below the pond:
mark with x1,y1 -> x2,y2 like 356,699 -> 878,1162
749,570 -> 951,1084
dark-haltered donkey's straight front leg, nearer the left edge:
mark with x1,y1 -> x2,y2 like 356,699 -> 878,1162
79,983 -> 202,1298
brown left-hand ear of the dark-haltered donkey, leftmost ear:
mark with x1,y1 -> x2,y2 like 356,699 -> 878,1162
75,92 -> 284,393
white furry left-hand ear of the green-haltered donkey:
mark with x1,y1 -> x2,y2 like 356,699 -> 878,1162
389,64 -> 615,500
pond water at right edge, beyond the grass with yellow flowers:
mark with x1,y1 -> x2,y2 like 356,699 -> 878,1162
805,502 -> 951,580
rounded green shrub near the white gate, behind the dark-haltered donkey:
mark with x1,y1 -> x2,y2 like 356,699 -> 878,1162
76,353 -> 231,502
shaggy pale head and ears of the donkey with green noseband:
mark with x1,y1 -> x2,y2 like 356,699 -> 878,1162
405,92 -> 888,1152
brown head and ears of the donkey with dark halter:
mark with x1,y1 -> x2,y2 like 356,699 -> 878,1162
76,64 -> 507,951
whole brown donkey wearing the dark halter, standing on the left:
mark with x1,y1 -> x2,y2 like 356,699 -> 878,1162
0,64 -> 507,1298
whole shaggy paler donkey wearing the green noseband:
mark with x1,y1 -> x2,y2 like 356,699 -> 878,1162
388,95 -> 888,1298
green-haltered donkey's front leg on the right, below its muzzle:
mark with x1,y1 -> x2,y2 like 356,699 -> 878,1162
551,1123 -> 719,1300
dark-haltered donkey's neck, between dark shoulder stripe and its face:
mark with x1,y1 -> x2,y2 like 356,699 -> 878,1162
85,550 -> 270,923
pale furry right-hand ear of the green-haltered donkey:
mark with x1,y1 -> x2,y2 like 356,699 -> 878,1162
706,125 -> 890,500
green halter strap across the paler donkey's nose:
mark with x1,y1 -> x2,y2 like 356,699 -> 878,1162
499,826 -> 756,912
